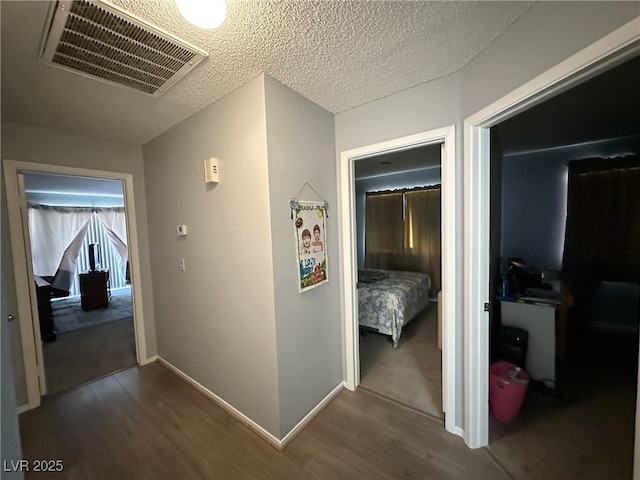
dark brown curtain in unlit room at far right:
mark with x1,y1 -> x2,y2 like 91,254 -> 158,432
562,156 -> 640,316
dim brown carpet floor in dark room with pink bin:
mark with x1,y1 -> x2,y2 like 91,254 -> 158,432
488,330 -> 638,480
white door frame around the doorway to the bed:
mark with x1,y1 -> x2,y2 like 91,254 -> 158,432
337,126 -> 461,435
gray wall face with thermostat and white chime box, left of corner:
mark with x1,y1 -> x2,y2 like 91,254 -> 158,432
143,76 -> 282,437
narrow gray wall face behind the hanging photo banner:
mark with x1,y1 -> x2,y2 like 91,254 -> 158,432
264,75 -> 342,436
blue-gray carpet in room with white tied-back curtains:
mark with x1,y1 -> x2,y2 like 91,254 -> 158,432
51,288 -> 133,334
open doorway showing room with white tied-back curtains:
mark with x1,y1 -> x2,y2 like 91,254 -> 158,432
22,172 -> 136,395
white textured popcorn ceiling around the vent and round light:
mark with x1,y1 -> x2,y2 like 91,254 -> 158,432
0,0 -> 534,145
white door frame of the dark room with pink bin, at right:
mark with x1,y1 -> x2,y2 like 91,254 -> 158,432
463,17 -> 640,448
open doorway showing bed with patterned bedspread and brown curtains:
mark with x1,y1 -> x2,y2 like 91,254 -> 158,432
355,144 -> 443,419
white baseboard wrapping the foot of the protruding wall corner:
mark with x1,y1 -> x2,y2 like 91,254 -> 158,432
156,356 -> 344,450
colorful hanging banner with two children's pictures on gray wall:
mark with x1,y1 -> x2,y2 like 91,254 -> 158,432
291,202 -> 329,292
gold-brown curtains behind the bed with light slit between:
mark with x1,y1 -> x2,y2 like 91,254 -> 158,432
365,185 -> 442,292
